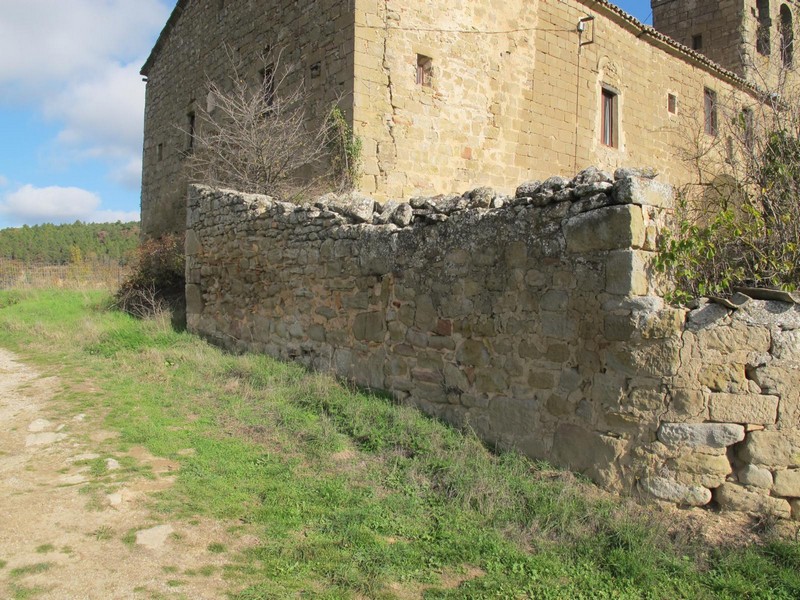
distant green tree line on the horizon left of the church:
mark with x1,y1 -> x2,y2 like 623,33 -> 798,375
0,221 -> 139,265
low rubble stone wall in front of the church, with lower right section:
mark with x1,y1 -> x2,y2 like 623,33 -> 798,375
186,169 -> 800,516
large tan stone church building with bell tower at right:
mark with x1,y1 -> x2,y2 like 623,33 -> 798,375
142,0 -> 798,235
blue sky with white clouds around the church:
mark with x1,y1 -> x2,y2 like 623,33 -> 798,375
0,0 -> 650,228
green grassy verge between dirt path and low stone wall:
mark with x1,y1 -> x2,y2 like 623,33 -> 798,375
0,292 -> 800,600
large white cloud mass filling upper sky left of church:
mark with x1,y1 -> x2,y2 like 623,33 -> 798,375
0,0 -> 175,198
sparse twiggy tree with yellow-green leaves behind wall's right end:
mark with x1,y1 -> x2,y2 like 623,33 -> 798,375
661,49 -> 800,299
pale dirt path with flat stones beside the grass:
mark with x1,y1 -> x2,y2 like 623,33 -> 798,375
0,349 -> 241,600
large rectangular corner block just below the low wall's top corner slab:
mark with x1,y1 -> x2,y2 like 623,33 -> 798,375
564,205 -> 645,253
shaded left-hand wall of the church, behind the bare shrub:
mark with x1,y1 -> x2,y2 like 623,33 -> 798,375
142,0 -> 354,237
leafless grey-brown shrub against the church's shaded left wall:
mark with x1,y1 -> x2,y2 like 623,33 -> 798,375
187,50 -> 354,199
